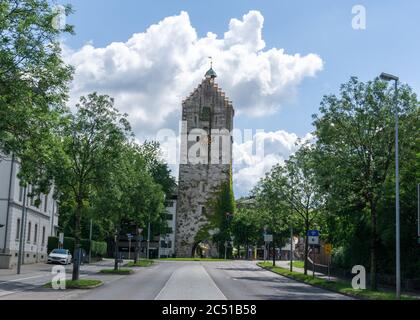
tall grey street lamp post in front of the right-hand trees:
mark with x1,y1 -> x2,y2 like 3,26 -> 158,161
380,73 -> 401,299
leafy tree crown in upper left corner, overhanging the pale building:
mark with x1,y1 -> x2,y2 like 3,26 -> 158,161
0,0 -> 73,192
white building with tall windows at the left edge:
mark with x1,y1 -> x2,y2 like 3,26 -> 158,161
0,154 -> 58,269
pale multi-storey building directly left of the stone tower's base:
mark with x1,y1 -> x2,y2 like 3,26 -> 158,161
159,195 -> 177,258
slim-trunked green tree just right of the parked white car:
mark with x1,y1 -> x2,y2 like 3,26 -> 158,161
52,93 -> 130,280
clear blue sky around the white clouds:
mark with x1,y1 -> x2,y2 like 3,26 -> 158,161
61,0 -> 420,193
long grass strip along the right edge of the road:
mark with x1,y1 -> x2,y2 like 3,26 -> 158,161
258,262 -> 418,300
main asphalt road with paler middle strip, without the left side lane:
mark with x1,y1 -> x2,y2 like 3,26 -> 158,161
78,261 -> 349,300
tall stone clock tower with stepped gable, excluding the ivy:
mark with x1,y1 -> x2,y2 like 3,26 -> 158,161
175,67 -> 234,257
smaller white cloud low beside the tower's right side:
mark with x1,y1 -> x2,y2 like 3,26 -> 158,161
233,130 -> 313,196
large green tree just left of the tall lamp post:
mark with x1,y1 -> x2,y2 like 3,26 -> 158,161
314,78 -> 418,289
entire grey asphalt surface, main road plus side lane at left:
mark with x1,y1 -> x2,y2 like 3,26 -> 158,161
0,261 -> 349,300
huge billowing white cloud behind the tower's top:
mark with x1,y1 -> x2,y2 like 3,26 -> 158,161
64,11 -> 323,140
